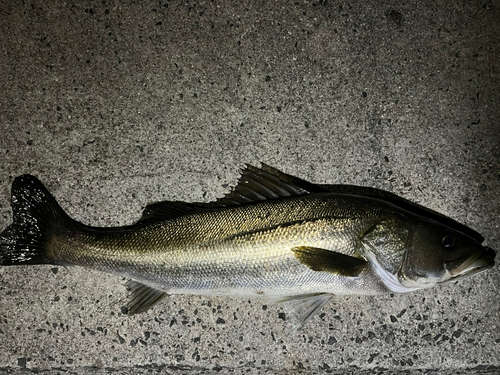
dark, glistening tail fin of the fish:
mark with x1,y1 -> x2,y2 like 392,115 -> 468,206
0,174 -> 71,266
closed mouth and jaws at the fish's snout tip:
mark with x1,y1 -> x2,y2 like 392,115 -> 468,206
444,247 -> 496,279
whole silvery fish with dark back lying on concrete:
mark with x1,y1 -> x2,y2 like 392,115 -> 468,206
0,164 -> 496,328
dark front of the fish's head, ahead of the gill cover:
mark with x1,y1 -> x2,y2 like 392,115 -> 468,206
397,219 -> 495,289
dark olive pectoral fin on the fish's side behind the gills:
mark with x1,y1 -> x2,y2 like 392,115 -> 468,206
292,246 -> 368,277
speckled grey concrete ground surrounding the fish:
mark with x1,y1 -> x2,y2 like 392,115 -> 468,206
0,0 -> 500,374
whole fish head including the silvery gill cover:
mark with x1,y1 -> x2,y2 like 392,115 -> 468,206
362,211 -> 495,292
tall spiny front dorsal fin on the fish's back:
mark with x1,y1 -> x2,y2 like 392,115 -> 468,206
217,164 -> 324,206
